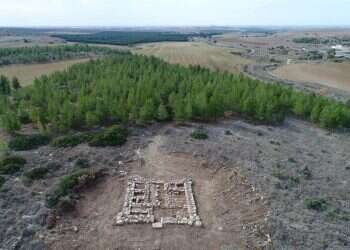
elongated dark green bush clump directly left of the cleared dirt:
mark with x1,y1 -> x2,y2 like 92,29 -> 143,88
47,171 -> 101,208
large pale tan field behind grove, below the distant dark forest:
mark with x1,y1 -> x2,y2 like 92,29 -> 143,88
133,42 -> 252,73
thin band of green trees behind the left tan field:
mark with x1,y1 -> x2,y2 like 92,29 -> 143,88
0,45 -> 117,66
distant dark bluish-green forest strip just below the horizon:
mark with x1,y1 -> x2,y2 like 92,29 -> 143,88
55,31 -> 217,45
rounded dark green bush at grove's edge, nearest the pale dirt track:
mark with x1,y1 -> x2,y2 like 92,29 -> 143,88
89,125 -> 128,147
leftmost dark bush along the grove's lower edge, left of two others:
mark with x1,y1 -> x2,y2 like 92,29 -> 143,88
8,134 -> 50,151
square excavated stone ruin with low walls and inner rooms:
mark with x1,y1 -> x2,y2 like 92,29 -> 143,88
116,176 -> 202,228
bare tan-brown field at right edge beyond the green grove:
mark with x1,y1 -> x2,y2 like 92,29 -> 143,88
271,63 -> 350,91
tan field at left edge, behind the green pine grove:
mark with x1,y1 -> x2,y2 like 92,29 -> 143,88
0,58 -> 90,86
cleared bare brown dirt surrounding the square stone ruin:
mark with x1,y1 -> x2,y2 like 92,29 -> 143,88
47,130 -> 267,250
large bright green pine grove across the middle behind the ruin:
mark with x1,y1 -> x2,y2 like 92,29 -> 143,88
0,52 -> 350,132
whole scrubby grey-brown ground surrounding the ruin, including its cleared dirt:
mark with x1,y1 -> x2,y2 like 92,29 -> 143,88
0,118 -> 350,250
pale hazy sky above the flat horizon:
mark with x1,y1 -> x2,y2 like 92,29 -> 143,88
0,0 -> 350,26
